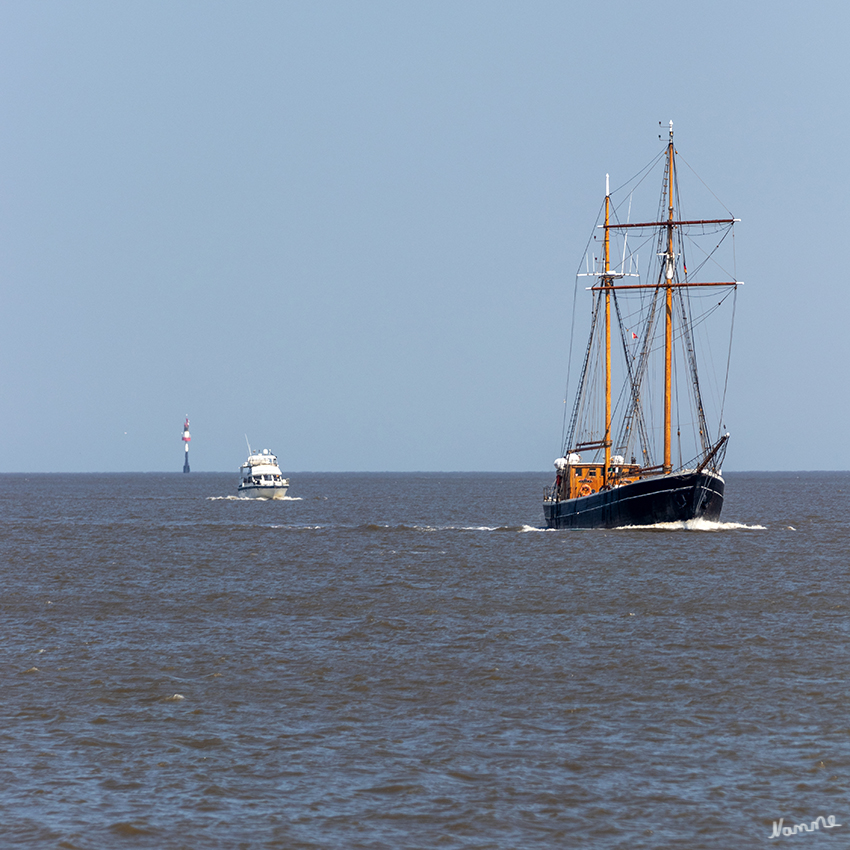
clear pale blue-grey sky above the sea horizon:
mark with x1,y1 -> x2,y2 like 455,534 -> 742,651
0,0 -> 850,472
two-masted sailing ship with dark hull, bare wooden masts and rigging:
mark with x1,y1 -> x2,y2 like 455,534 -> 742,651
543,121 -> 741,528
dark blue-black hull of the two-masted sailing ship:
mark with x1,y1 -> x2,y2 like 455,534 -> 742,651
543,472 -> 725,528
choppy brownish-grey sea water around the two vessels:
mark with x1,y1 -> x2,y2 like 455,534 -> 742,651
0,473 -> 850,850
